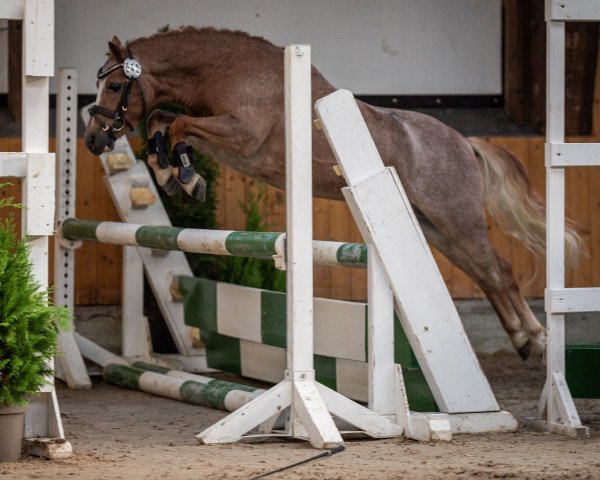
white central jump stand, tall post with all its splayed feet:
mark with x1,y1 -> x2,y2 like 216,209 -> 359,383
197,45 -> 402,448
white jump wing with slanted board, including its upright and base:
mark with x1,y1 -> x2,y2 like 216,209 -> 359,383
315,90 -> 517,440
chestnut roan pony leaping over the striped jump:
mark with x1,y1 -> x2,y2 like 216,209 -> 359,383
85,27 -> 580,359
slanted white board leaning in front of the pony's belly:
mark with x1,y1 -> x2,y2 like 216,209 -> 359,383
316,90 -> 499,413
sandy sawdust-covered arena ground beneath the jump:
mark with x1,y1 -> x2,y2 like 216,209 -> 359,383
0,352 -> 600,480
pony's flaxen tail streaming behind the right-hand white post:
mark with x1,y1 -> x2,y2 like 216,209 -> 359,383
467,137 -> 585,266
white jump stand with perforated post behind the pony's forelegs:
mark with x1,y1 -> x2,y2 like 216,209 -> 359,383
54,69 -> 210,374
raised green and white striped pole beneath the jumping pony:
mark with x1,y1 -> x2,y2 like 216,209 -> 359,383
61,218 -> 367,268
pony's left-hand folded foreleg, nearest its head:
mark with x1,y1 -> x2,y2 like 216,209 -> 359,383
146,110 -> 180,196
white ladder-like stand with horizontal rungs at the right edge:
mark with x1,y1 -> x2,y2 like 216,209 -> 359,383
538,0 -> 600,437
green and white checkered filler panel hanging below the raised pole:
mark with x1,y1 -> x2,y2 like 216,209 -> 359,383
179,277 -> 437,411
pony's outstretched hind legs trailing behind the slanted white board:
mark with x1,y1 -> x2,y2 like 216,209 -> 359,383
420,210 -> 546,359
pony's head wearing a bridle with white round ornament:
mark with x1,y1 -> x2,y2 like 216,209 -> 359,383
84,37 -> 145,155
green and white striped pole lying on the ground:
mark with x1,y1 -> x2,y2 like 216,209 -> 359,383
103,362 -> 264,412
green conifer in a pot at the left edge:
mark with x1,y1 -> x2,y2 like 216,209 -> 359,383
0,198 -> 69,462
